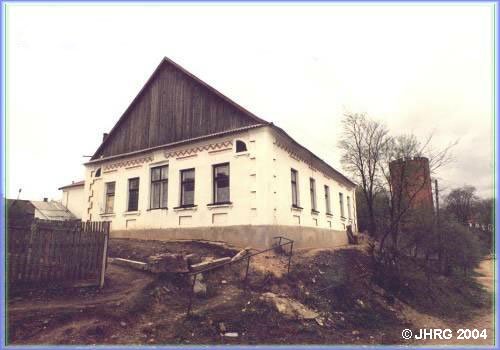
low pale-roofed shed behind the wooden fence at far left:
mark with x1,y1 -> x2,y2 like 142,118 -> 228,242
7,198 -> 77,221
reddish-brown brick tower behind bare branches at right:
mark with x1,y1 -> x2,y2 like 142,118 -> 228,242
389,157 -> 434,213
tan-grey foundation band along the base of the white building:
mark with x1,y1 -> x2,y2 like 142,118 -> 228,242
110,225 -> 348,249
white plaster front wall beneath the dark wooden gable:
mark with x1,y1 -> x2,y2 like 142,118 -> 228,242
83,128 -> 272,230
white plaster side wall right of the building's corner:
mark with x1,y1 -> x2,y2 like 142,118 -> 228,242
270,129 -> 357,231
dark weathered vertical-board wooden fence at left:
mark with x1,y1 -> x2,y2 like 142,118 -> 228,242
7,219 -> 109,290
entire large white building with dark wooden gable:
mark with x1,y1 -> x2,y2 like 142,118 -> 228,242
82,58 -> 357,247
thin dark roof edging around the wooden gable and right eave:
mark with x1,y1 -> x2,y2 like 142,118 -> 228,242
89,57 -> 356,188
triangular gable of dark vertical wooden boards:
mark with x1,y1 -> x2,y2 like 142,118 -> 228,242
92,60 -> 266,159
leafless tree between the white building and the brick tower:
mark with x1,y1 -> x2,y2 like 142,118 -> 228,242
339,114 -> 390,235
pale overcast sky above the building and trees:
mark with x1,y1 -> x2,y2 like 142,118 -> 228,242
6,3 -> 494,200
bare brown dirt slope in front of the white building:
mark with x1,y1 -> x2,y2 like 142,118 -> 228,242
7,239 -> 493,345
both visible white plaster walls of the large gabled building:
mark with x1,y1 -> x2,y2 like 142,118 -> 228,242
83,127 -> 357,231
